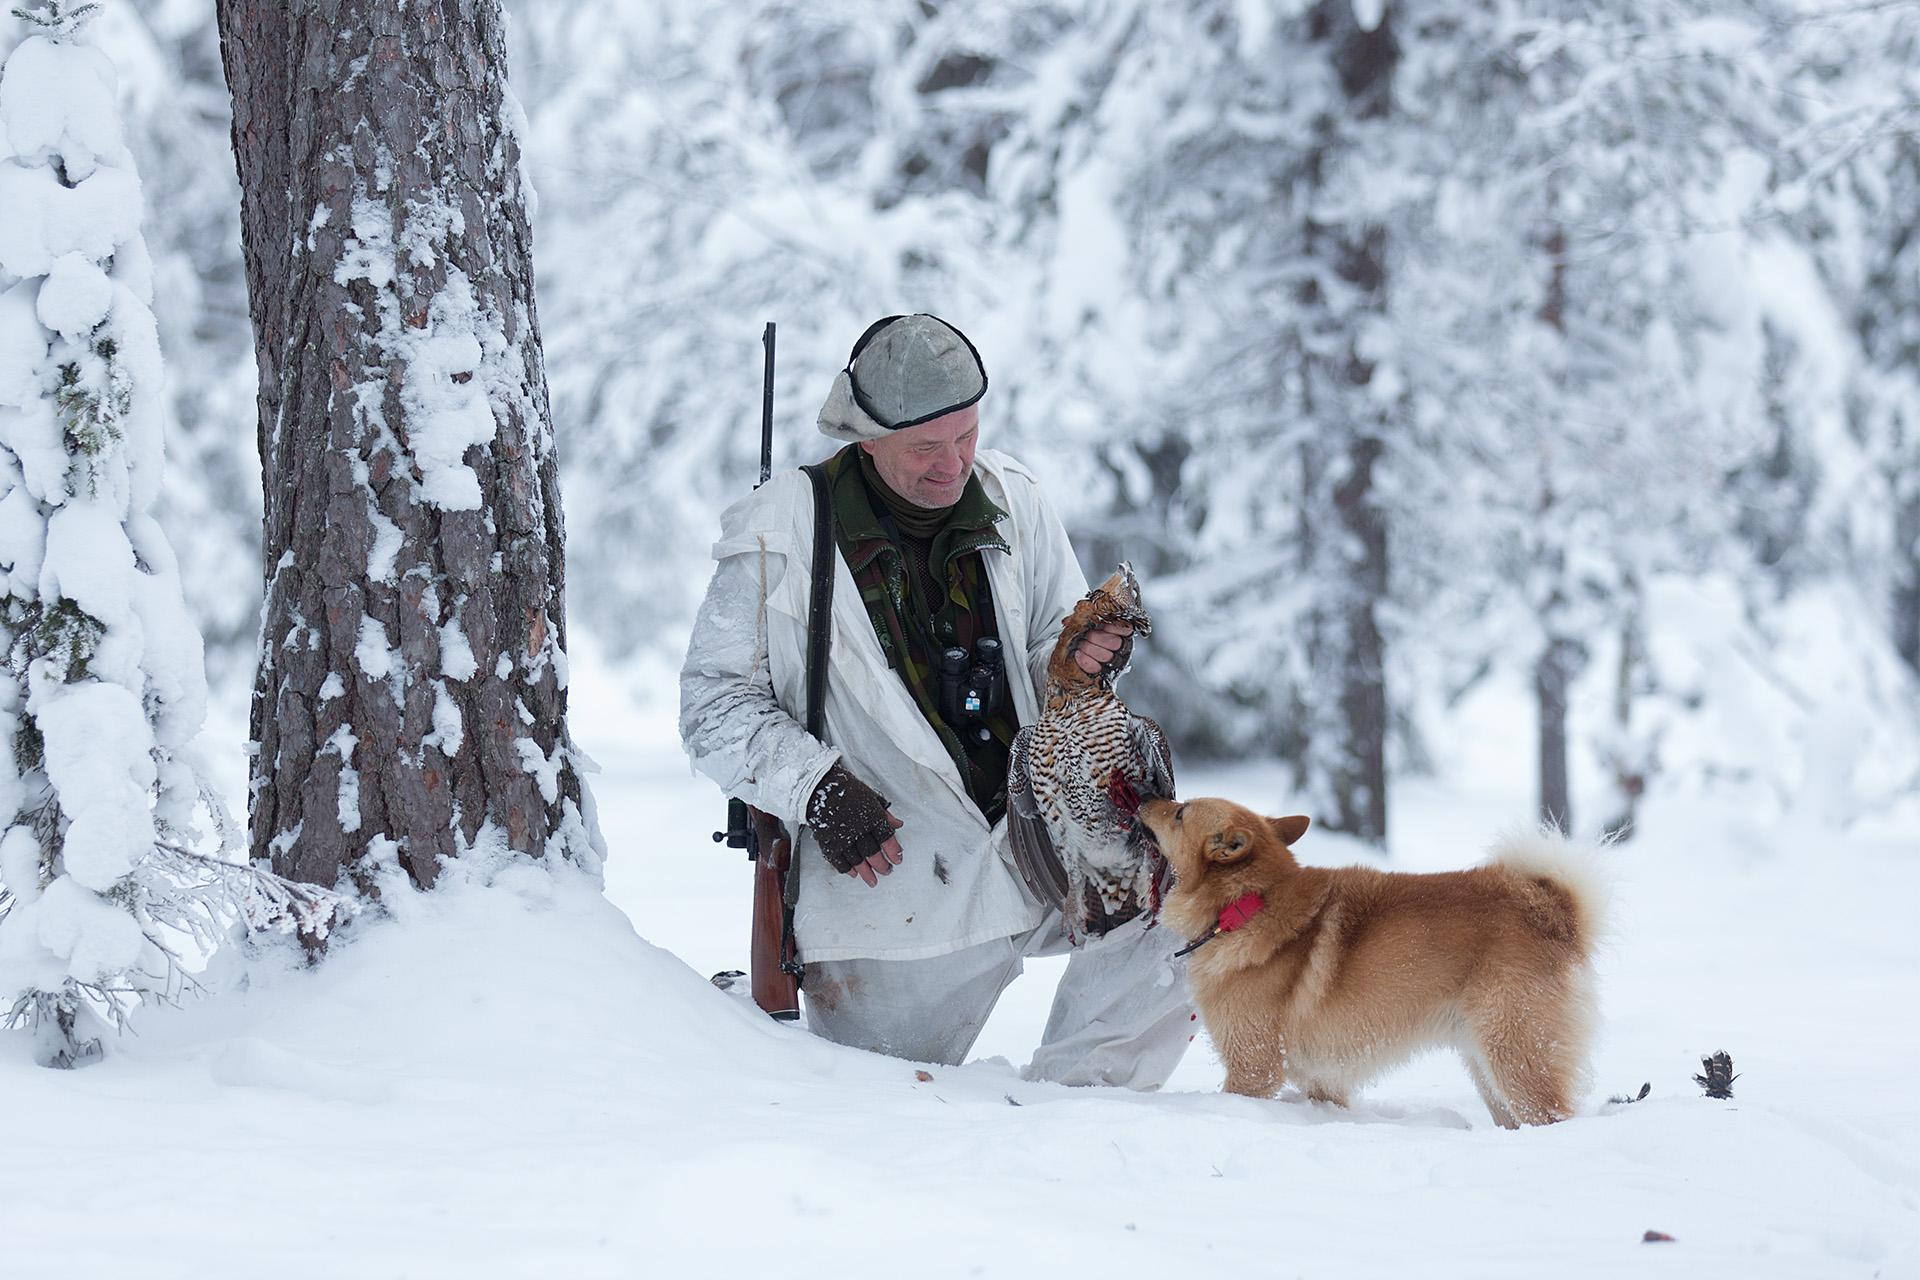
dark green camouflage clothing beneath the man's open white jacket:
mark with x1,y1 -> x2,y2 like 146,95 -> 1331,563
828,445 -> 1025,821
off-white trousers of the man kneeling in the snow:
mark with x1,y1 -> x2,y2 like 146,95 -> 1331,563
803,912 -> 1196,1090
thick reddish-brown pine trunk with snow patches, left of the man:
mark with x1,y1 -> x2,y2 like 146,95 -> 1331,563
219,0 -> 599,901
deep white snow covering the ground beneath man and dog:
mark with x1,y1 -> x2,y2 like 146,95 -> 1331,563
0,662 -> 1920,1280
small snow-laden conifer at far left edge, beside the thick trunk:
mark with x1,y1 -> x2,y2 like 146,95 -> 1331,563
0,0 -> 259,1065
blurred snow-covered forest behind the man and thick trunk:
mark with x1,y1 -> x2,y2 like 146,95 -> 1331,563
0,0 -> 1920,835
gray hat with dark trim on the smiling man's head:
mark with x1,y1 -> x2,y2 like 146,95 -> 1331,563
820,315 -> 987,439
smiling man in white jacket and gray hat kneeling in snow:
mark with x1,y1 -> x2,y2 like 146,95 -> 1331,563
680,315 -> 1188,1088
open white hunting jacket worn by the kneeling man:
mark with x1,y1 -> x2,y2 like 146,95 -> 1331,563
680,449 -> 1087,960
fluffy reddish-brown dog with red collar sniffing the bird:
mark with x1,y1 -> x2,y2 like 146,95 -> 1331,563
1140,800 -> 1601,1128
